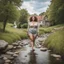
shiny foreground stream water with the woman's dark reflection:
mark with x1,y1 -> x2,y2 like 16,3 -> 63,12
14,46 -> 64,64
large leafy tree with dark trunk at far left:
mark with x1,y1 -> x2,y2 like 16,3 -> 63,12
0,0 -> 22,31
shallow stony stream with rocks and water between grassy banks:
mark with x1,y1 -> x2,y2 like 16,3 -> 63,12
0,34 -> 64,64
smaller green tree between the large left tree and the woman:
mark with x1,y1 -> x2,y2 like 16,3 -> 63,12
19,9 -> 29,27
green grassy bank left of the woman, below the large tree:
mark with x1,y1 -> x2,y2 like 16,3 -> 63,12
0,23 -> 27,43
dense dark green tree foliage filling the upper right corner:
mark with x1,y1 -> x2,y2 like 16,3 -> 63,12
46,0 -> 64,25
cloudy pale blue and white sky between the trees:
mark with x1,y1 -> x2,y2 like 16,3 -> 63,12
21,0 -> 50,14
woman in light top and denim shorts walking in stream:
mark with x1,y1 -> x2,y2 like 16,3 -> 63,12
28,16 -> 39,50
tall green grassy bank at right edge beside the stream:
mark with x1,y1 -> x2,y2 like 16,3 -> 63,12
44,29 -> 64,54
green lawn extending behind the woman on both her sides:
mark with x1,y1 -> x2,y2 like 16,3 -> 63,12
0,22 -> 61,43
